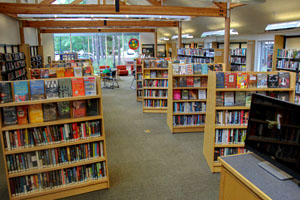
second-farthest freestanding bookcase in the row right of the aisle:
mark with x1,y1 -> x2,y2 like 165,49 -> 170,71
143,59 -> 168,113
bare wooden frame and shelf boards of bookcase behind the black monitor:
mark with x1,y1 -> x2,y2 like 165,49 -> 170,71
203,71 -> 296,172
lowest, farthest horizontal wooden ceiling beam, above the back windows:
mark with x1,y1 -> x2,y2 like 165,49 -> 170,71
41,28 -> 155,33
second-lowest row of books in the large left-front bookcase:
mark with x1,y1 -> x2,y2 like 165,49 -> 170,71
6,141 -> 104,173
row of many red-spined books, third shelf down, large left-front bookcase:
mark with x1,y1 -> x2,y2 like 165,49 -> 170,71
3,121 -> 102,151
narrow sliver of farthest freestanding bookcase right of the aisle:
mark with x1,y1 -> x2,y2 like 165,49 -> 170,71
135,58 -> 144,101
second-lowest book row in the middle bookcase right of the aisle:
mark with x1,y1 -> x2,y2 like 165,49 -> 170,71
173,102 -> 206,113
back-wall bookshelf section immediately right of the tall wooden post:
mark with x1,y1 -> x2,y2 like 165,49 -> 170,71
230,48 -> 247,71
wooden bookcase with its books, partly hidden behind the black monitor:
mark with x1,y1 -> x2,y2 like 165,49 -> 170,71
203,71 -> 296,172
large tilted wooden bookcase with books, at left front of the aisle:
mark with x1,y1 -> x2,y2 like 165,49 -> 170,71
0,76 -> 110,200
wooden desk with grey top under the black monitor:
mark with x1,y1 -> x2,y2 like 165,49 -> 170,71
219,153 -> 300,200
